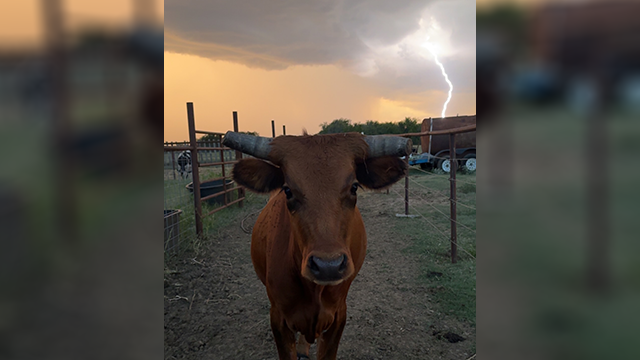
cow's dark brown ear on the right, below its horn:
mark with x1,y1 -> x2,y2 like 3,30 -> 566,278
356,156 -> 407,189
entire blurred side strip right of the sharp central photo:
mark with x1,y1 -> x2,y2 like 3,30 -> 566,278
477,1 -> 640,359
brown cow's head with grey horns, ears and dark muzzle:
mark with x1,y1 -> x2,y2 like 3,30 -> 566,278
223,132 -> 411,285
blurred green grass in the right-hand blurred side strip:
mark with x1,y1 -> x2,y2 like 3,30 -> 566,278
482,107 -> 640,359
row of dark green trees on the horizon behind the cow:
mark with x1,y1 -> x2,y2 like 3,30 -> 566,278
319,117 -> 422,145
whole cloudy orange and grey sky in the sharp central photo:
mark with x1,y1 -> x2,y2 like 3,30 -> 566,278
164,0 -> 476,141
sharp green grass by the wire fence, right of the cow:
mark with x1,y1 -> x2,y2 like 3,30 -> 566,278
395,170 -> 476,326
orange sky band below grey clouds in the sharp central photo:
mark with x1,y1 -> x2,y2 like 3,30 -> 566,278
164,52 -> 475,141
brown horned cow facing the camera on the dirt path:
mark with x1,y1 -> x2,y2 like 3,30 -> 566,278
223,132 -> 411,360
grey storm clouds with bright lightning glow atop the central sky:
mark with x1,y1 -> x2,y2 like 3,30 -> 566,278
165,0 -> 475,93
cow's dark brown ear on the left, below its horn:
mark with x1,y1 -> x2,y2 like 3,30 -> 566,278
233,159 -> 284,193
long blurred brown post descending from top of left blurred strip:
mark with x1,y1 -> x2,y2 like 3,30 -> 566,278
41,0 -> 77,244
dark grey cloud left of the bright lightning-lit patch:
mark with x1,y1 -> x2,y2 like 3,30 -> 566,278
165,0 -> 428,68
